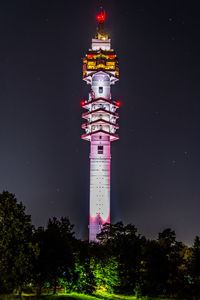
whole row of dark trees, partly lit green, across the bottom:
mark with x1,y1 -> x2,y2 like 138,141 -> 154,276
0,192 -> 200,299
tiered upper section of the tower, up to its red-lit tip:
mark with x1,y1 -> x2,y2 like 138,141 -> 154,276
81,11 -> 120,141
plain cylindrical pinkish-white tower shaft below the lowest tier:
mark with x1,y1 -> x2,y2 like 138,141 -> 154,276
89,136 -> 111,241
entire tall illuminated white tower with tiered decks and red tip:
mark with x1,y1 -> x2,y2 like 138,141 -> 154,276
81,11 -> 120,242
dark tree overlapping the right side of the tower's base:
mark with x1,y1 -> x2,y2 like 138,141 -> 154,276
97,222 -> 145,294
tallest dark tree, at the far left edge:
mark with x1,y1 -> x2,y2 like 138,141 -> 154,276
0,191 -> 38,294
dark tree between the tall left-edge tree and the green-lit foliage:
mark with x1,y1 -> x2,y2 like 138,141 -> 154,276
34,217 -> 75,294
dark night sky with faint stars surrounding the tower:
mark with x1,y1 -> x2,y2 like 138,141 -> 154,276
0,0 -> 200,243
